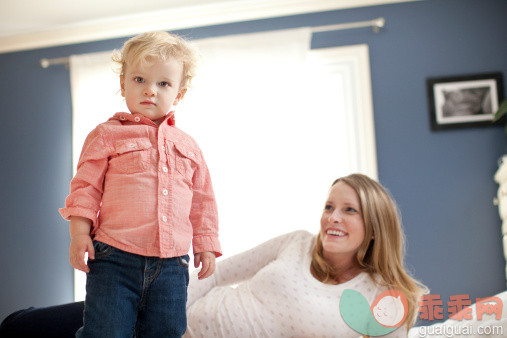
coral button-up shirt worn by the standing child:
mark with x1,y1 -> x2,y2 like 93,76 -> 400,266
60,113 -> 221,258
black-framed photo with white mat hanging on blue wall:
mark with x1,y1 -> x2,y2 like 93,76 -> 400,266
426,73 -> 503,130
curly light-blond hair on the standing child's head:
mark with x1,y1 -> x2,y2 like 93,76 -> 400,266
112,32 -> 199,91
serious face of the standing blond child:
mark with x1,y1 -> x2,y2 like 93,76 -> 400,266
120,58 -> 185,121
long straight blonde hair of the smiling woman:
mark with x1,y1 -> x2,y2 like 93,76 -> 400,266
312,174 -> 428,329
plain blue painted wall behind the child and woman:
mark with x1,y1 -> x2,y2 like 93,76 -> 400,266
0,0 -> 507,319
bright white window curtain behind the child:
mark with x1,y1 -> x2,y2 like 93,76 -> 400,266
70,29 -> 377,300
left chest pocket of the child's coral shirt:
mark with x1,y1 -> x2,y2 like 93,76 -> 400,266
109,139 -> 151,174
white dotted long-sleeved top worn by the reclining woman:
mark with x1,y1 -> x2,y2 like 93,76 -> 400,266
184,231 -> 407,338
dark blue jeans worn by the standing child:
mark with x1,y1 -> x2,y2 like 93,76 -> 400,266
76,241 -> 189,338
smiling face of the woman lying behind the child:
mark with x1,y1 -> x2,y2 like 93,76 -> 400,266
320,181 -> 365,263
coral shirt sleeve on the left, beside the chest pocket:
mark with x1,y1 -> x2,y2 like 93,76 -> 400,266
59,127 -> 110,226
